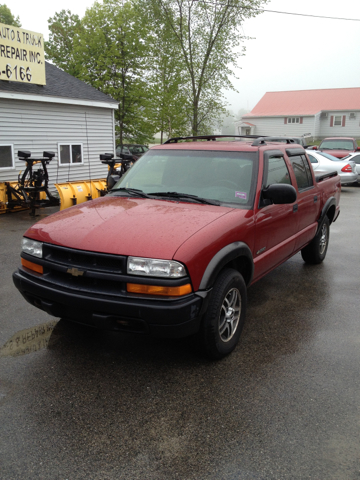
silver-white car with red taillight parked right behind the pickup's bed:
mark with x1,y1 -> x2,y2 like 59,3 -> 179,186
306,150 -> 360,185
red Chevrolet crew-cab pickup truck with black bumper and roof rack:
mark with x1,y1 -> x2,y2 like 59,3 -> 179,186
13,136 -> 340,358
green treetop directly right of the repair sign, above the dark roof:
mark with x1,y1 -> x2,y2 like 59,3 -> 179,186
45,10 -> 82,77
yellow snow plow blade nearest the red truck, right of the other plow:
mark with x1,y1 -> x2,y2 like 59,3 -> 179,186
55,178 -> 106,210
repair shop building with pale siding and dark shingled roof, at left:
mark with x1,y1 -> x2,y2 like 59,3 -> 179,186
0,63 -> 118,188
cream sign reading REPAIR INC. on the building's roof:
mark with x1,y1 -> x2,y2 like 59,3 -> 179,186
0,23 -> 46,85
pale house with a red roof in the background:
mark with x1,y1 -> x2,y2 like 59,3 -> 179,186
235,88 -> 360,139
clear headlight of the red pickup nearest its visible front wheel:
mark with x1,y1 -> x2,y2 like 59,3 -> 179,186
127,257 -> 186,278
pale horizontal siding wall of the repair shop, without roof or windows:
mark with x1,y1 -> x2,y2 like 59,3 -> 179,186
0,99 -> 115,190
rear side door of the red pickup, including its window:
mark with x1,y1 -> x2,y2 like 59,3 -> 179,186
286,148 -> 321,250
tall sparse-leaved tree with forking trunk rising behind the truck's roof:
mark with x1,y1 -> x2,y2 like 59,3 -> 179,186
139,0 -> 267,135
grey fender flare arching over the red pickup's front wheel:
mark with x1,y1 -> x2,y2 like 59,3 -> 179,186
199,242 -> 254,290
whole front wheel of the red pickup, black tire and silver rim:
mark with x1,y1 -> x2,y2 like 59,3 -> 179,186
201,268 -> 247,359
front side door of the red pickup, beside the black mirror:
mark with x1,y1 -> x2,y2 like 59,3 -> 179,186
254,150 -> 297,280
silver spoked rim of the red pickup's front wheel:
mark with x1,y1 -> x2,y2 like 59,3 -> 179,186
219,288 -> 241,342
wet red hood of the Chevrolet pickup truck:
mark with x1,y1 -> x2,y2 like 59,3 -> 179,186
25,197 -> 233,259
